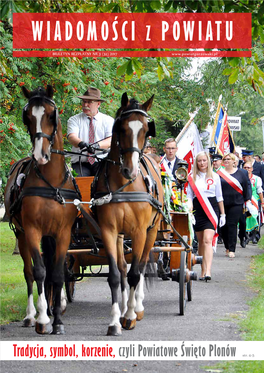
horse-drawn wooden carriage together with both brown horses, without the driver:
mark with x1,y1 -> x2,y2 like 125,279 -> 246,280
5,86 -> 201,336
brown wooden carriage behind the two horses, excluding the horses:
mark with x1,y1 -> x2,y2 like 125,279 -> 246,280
65,173 -> 202,315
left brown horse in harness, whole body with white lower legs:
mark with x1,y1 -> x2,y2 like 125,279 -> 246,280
5,86 -> 78,334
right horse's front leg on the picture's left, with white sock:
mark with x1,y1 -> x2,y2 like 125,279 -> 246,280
102,229 -> 122,336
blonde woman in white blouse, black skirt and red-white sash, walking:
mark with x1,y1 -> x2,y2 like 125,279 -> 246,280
187,151 -> 225,281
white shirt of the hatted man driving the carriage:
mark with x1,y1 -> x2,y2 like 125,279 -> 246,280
67,112 -> 114,163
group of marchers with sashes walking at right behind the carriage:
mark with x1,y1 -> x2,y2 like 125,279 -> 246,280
163,144 -> 264,281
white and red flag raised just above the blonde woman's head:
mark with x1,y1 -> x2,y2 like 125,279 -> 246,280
176,118 -> 203,173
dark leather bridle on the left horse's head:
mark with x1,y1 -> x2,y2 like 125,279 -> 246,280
22,95 -> 59,147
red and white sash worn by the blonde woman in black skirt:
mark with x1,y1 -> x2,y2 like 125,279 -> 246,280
188,175 -> 219,252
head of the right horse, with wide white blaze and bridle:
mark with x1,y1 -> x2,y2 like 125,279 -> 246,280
113,93 -> 156,179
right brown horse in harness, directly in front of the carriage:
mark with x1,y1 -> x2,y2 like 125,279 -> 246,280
94,93 -> 163,335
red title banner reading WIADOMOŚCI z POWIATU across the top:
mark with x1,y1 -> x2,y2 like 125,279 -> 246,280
13,13 -> 252,57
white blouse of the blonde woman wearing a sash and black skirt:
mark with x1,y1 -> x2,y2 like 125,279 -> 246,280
187,172 -> 224,202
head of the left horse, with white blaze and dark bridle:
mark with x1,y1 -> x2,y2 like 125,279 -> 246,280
22,85 -> 59,165
